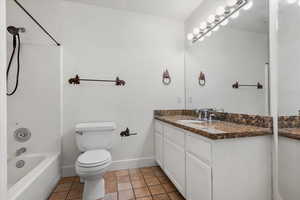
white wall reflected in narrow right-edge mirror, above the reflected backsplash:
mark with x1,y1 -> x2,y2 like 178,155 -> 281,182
278,4 -> 300,115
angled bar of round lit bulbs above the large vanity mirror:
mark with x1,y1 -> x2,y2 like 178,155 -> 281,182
187,0 -> 253,43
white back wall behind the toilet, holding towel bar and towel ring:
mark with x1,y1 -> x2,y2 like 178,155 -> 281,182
61,2 -> 184,175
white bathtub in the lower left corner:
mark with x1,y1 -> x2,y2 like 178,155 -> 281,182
7,153 -> 61,200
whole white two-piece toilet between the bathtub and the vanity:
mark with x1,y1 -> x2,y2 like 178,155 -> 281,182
75,122 -> 116,200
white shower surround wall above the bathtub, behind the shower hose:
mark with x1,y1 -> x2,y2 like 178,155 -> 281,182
7,0 -> 60,156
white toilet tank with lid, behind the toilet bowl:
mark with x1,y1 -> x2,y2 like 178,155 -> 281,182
75,122 -> 116,152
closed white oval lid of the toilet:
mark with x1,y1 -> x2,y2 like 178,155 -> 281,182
77,150 -> 111,166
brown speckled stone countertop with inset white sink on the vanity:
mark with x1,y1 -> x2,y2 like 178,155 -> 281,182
154,115 -> 272,140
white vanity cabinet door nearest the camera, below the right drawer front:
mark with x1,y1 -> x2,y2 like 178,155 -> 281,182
186,153 -> 212,200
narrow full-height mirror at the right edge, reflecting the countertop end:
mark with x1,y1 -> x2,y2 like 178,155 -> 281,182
278,0 -> 300,200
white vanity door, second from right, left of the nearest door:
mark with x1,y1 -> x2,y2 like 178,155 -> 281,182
164,138 -> 185,196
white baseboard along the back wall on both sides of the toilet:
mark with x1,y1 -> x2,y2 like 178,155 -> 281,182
62,157 -> 157,177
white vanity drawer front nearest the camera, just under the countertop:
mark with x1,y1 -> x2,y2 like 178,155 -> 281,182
186,134 -> 211,165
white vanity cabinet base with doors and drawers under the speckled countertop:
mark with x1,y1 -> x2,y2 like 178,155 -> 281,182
155,120 -> 272,200
